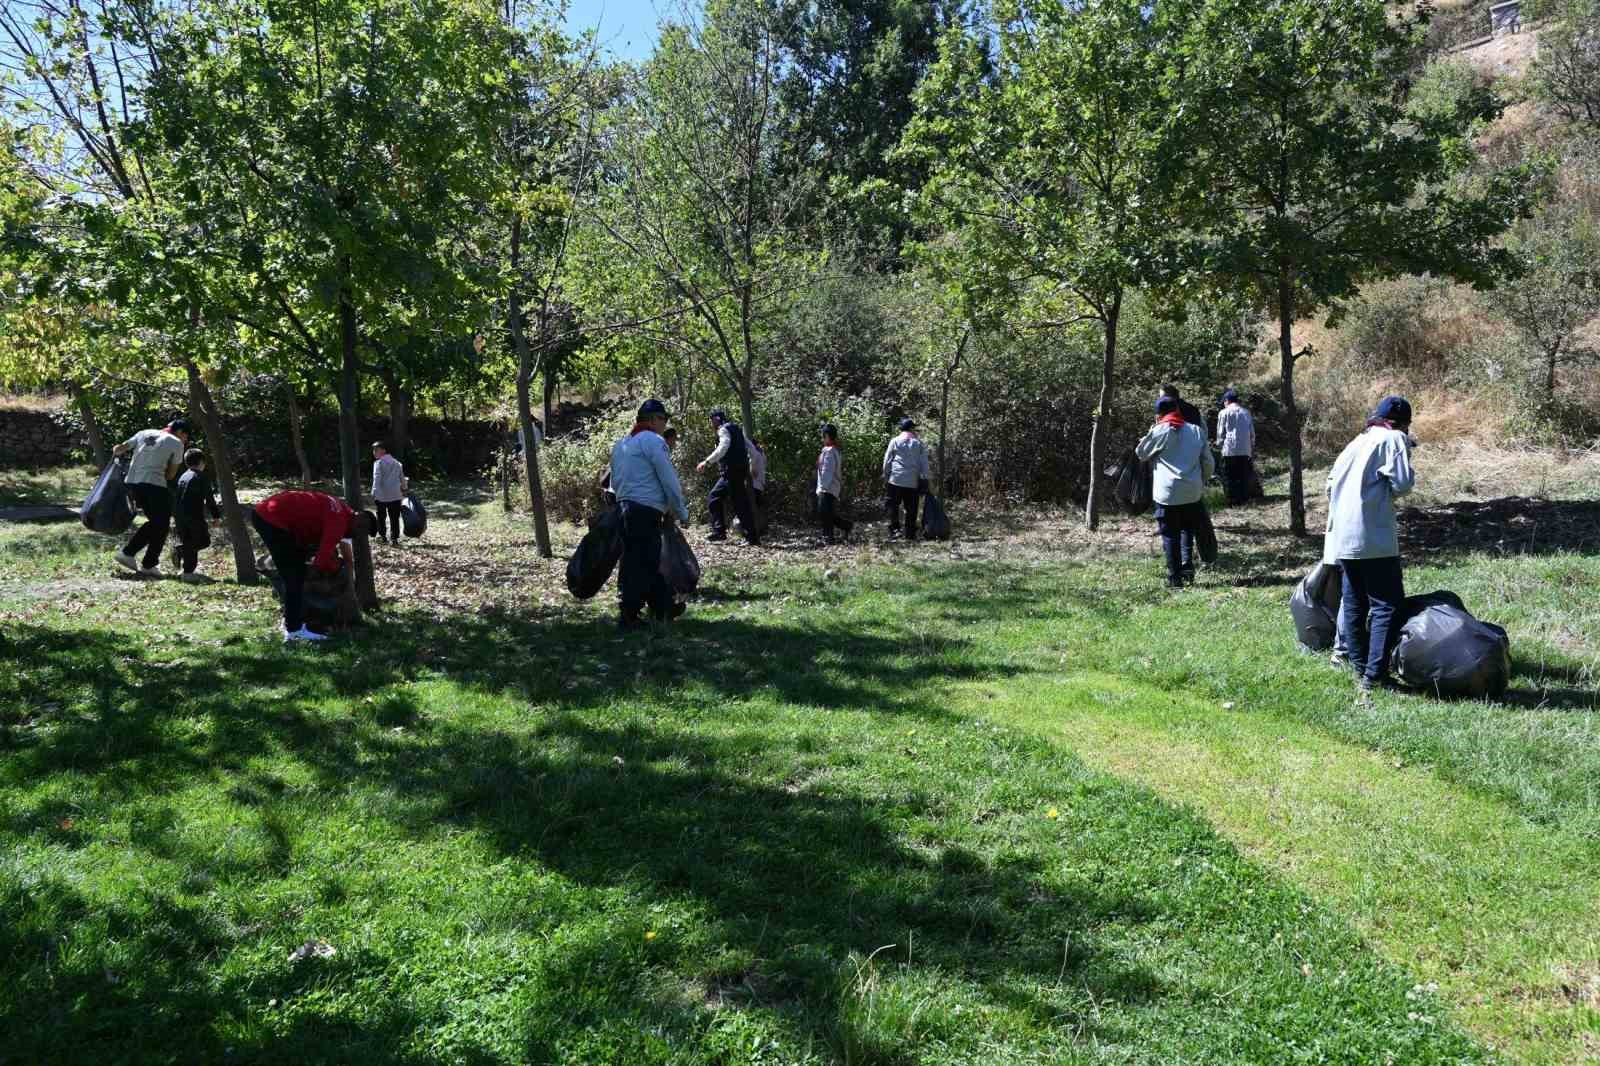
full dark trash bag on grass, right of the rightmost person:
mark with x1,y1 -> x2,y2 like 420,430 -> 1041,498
1389,592 -> 1510,699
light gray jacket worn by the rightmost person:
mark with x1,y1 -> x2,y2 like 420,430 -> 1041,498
1322,426 -> 1416,562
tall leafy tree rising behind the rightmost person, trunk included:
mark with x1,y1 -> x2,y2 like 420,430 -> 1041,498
1174,0 -> 1526,535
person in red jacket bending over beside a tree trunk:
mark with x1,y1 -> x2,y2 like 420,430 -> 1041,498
250,490 -> 378,642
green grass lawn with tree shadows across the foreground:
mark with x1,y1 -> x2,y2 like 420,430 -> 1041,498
0,475 -> 1600,1066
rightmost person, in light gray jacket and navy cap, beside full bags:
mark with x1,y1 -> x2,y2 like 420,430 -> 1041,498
1323,395 -> 1416,699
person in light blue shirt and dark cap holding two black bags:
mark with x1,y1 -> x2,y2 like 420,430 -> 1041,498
611,400 -> 688,632
